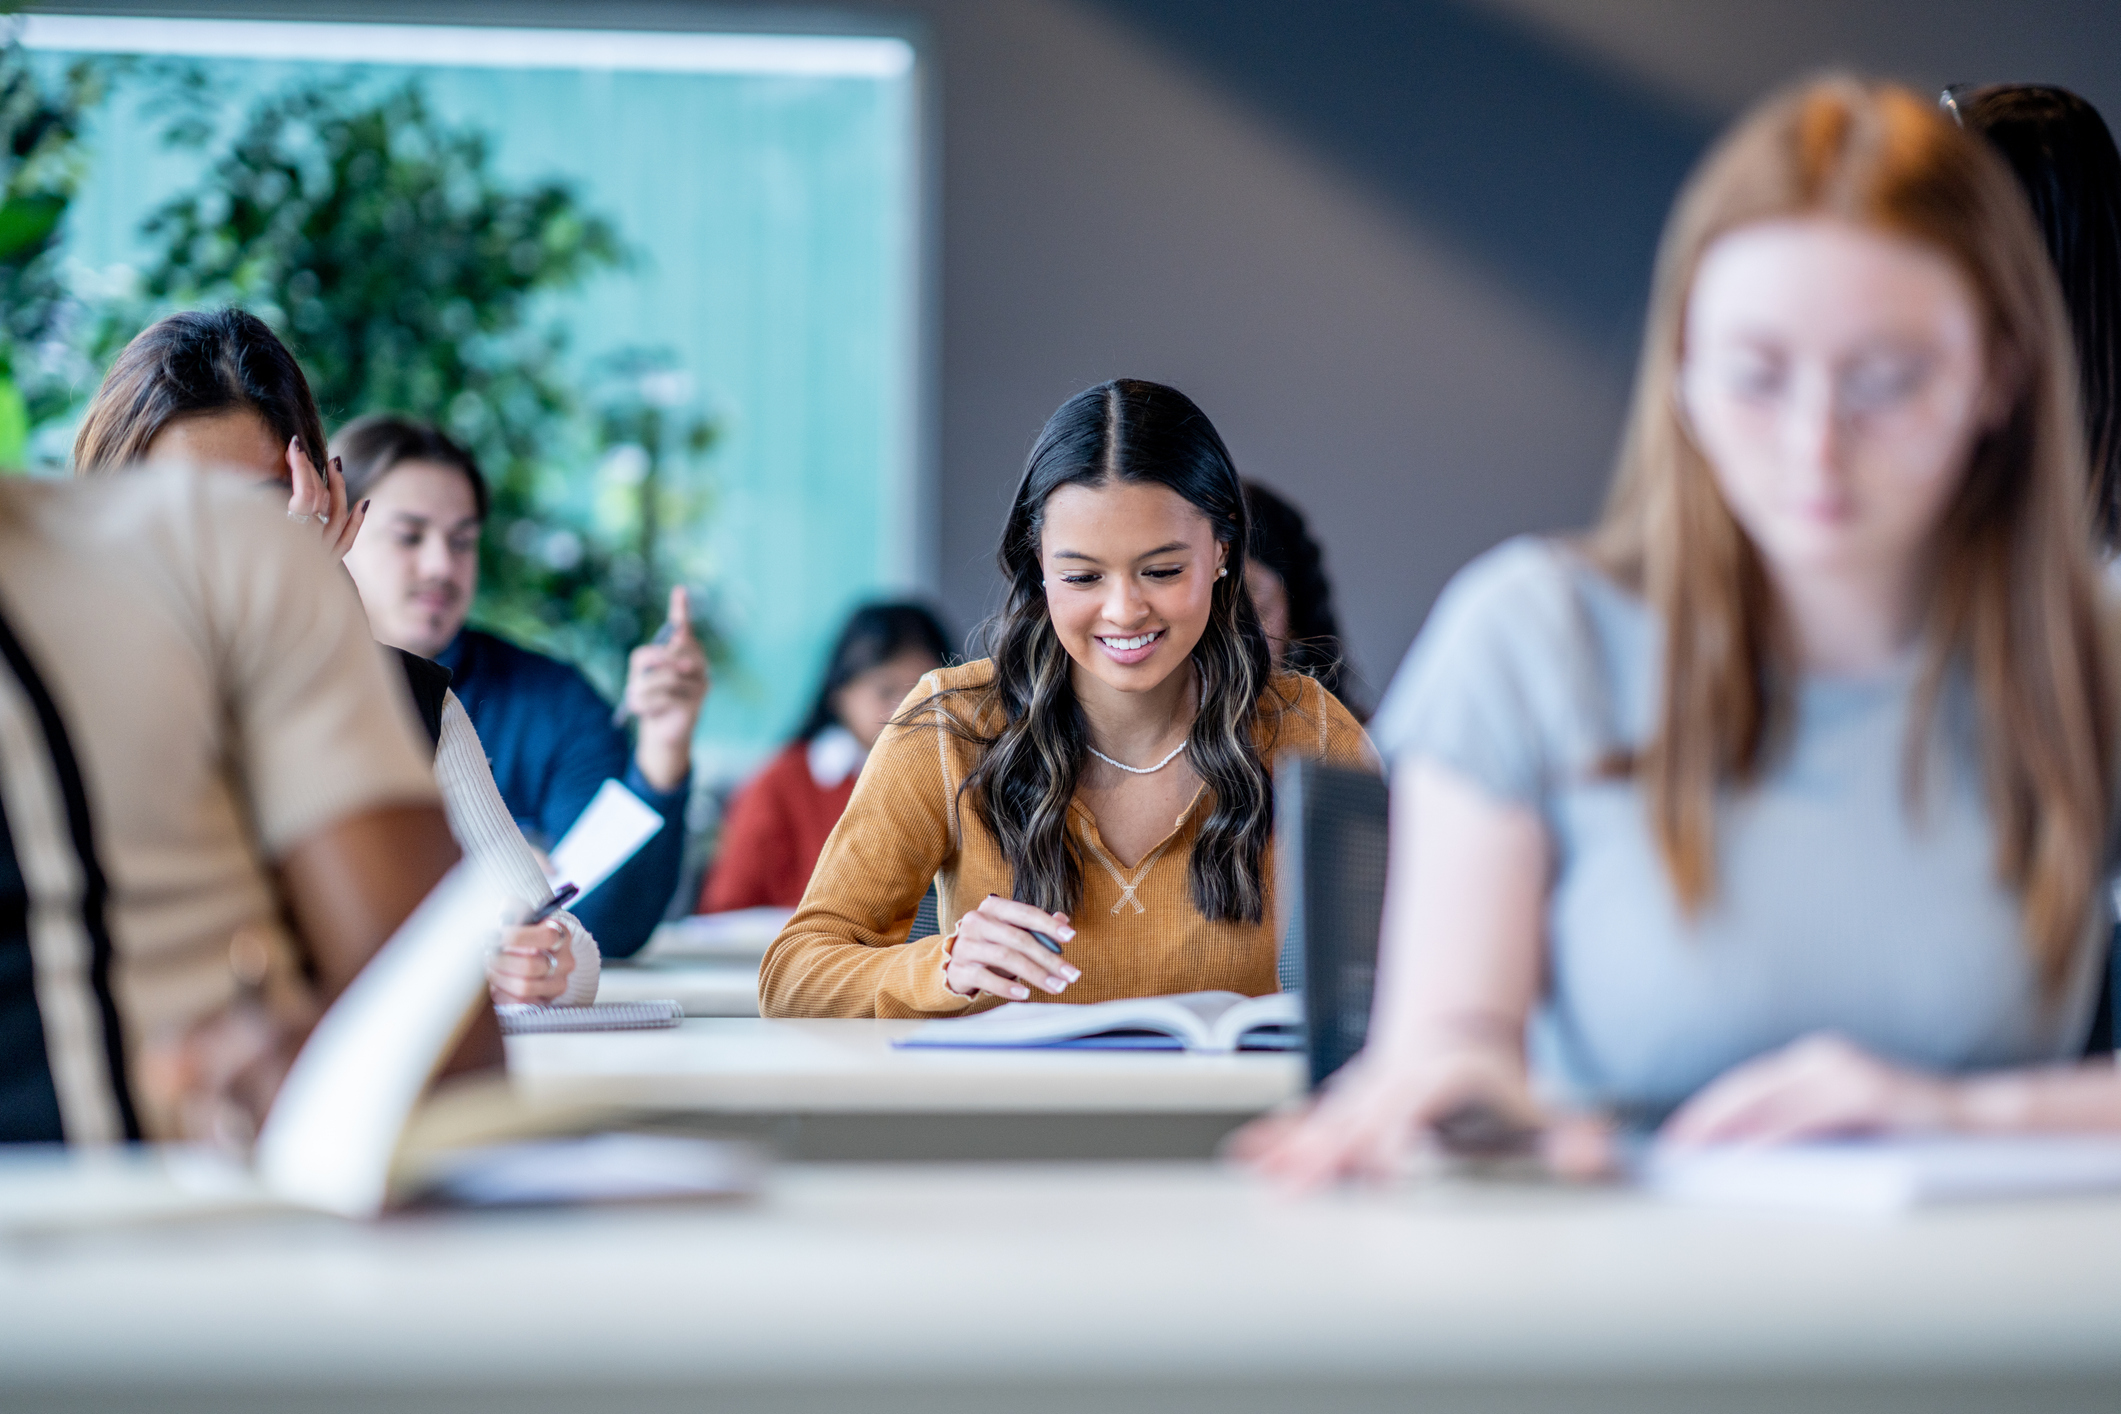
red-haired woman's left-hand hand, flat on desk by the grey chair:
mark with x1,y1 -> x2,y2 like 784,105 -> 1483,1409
1230,1041 -> 1546,1189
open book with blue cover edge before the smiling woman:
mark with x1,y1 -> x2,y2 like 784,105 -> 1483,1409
893,992 -> 1304,1051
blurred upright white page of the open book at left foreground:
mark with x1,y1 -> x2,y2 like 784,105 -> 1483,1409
257,865 -> 509,1217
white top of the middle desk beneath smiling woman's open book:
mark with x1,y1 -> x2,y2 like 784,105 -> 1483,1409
507,1018 -> 1304,1115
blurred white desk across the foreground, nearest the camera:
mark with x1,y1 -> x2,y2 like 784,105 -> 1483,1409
0,1164 -> 2121,1414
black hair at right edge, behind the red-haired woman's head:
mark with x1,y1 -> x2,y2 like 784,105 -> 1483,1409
1951,83 -> 2121,547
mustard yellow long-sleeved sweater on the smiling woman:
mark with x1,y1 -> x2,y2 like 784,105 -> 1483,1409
759,659 -> 1377,1018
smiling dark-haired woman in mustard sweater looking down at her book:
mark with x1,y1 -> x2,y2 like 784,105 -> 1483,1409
759,379 -> 1374,1018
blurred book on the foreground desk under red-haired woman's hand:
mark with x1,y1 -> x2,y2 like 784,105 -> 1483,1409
1640,1134 -> 2121,1213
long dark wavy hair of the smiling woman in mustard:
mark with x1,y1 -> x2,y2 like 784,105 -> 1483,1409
928,377 -> 1275,922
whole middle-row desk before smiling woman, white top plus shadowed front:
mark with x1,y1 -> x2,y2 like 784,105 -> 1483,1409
509,1018 -> 1302,1160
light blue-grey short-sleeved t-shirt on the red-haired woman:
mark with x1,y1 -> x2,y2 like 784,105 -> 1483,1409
1370,538 -> 2110,1111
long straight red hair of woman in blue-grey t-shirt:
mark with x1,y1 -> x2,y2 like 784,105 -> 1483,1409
1589,76 -> 2117,990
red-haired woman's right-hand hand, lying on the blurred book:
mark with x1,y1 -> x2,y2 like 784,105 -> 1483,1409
1659,1032 -> 1958,1145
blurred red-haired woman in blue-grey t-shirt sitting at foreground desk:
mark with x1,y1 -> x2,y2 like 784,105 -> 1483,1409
1247,78 -> 2121,1181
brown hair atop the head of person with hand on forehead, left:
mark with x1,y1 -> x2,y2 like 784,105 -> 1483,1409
74,310 -> 325,477
